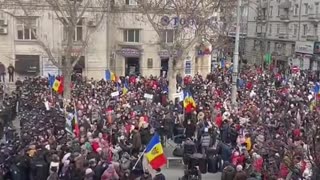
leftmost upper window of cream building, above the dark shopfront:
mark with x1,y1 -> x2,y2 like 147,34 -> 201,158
16,18 -> 37,40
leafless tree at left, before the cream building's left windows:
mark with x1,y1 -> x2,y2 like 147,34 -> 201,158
0,0 -> 110,99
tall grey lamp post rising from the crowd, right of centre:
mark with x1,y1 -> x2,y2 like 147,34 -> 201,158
231,0 -> 241,107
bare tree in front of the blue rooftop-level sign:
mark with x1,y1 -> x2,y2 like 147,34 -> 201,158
137,0 -> 235,99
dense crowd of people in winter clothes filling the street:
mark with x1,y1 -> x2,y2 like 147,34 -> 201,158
0,67 -> 320,180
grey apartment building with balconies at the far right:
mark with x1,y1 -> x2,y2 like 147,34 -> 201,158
245,0 -> 320,70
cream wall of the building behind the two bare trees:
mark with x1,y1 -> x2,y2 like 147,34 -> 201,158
0,1 -> 211,79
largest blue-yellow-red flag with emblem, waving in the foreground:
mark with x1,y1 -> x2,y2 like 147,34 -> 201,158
145,133 -> 167,169
